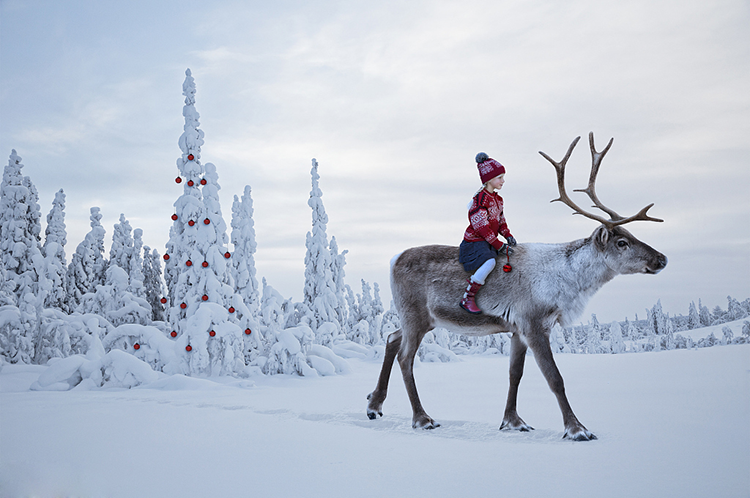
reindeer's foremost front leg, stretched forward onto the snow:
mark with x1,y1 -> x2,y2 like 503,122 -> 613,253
527,327 -> 596,441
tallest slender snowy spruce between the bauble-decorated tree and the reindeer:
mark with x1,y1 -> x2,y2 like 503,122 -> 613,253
303,159 -> 341,346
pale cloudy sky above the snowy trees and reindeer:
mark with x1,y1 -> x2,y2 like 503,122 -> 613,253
0,0 -> 750,322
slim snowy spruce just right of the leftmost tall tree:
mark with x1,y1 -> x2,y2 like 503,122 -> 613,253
42,189 -> 71,313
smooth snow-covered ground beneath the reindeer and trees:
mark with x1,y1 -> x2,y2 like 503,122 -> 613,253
0,345 -> 750,498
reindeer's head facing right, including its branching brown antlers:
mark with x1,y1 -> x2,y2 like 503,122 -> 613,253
539,132 -> 667,275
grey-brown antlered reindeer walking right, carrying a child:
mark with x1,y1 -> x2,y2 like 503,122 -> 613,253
367,133 -> 667,441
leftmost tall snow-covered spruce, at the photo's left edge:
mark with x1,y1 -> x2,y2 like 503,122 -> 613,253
0,150 -> 51,363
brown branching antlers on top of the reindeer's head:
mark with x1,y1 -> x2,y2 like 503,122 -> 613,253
539,132 -> 664,229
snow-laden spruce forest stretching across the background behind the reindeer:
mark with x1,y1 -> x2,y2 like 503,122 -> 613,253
0,70 -> 750,389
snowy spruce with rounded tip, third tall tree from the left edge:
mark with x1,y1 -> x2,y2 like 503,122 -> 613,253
67,207 -> 107,310
